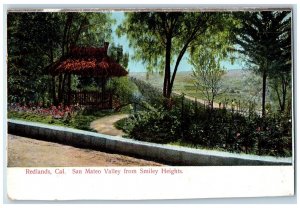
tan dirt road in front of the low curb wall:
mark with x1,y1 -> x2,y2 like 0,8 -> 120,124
7,135 -> 161,167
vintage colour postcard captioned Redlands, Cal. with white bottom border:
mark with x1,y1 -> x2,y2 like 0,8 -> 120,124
5,6 -> 295,201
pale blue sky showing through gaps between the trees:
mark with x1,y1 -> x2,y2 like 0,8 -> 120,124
112,12 -> 243,72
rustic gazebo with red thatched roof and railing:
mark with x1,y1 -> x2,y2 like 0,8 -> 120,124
49,42 -> 128,109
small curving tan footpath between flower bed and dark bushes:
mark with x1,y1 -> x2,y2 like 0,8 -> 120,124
90,114 -> 129,136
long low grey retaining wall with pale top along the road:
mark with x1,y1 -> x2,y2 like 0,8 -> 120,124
8,119 -> 292,166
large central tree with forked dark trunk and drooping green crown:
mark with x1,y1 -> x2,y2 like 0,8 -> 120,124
118,12 -> 227,101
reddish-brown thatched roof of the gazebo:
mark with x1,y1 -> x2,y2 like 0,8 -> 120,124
49,43 -> 128,77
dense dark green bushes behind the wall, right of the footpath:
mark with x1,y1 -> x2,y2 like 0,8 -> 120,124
116,81 -> 292,156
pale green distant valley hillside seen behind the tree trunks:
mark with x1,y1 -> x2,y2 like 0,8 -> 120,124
130,70 -> 261,108
